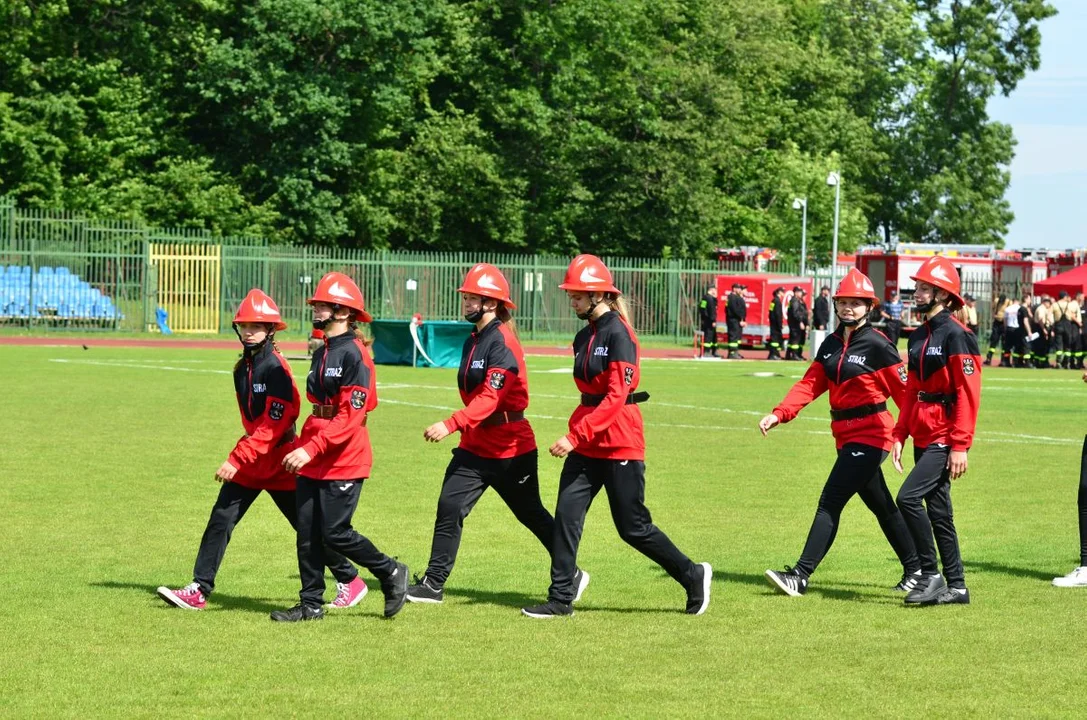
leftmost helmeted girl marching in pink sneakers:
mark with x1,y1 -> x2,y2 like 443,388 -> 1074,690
159,289 -> 366,610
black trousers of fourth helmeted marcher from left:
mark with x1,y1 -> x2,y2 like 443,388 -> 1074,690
548,456 -> 691,604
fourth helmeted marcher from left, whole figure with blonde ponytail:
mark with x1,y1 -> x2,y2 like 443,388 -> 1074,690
522,255 -> 708,619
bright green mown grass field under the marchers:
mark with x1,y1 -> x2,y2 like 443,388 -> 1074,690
0,346 -> 1087,718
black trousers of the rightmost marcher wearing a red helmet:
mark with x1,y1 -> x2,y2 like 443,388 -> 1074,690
898,445 -> 966,587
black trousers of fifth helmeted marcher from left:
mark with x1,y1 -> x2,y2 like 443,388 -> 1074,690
797,443 -> 921,575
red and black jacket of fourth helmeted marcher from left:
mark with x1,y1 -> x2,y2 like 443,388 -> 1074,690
566,311 -> 646,460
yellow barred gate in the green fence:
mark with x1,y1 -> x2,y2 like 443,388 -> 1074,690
150,243 -> 222,333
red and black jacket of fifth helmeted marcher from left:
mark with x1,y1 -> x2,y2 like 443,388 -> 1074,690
774,324 -> 907,450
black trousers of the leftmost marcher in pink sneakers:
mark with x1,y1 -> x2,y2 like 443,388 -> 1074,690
192,483 -> 359,596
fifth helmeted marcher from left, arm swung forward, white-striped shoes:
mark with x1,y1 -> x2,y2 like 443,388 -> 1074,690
759,268 -> 921,597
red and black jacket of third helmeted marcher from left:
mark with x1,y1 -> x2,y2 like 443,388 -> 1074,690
446,320 -> 536,458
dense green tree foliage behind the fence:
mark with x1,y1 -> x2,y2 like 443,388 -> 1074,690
0,0 -> 1054,257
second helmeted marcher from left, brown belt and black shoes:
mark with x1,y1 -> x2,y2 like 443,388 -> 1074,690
272,272 -> 408,622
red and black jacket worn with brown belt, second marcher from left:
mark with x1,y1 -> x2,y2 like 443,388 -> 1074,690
300,333 -> 377,480
